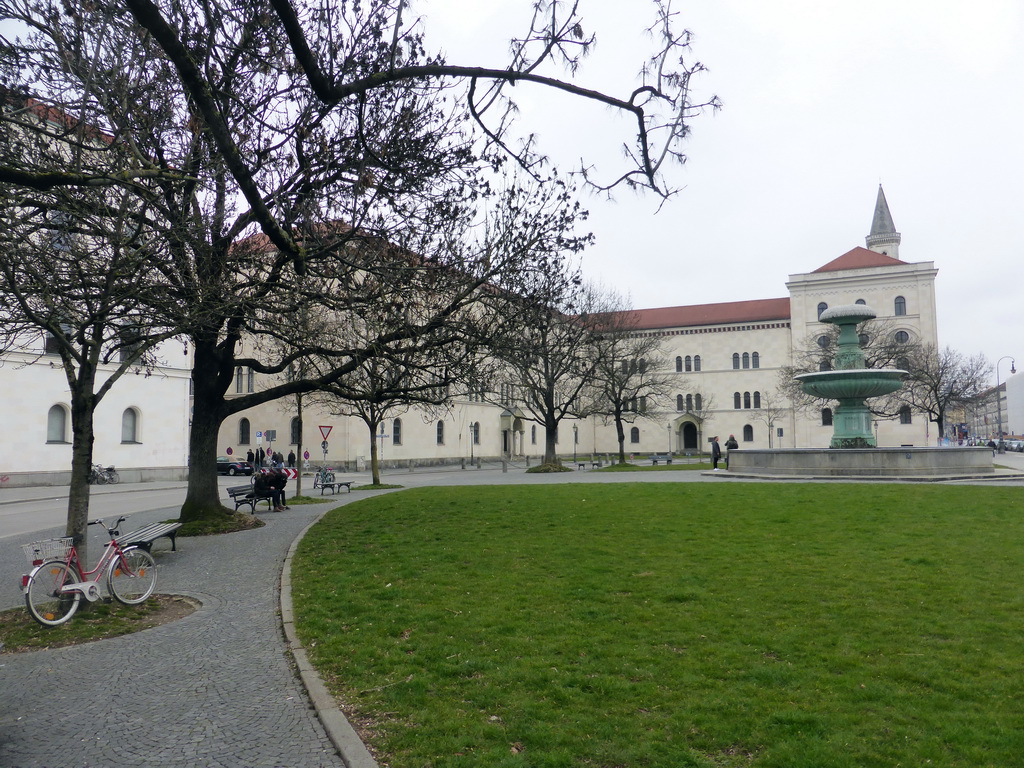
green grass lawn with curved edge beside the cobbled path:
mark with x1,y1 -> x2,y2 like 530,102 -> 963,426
293,483 -> 1024,768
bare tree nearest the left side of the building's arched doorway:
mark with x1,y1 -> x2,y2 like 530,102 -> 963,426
587,288 -> 670,464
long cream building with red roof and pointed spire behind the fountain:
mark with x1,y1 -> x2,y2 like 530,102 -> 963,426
218,186 -> 940,462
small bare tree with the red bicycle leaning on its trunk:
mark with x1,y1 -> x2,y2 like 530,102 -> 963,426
0,102 -> 175,562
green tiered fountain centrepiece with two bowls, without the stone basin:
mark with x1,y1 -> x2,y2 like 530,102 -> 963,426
796,304 -> 906,449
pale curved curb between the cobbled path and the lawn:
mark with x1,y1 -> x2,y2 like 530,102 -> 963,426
280,510 -> 379,768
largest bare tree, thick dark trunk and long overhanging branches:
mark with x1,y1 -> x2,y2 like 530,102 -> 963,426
0,0 -> 700,521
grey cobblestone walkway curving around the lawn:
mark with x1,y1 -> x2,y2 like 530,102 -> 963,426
0,456 -> 1024,768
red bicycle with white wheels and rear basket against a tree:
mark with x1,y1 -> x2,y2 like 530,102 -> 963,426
22,517 -> 157,627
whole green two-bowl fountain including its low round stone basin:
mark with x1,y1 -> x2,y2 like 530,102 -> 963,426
716,304 -> 993,480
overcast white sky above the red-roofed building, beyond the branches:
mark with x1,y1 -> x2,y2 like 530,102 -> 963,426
425,0 -> 1024,381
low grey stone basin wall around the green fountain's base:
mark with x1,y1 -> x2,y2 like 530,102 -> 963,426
729,447 -> 995,477
